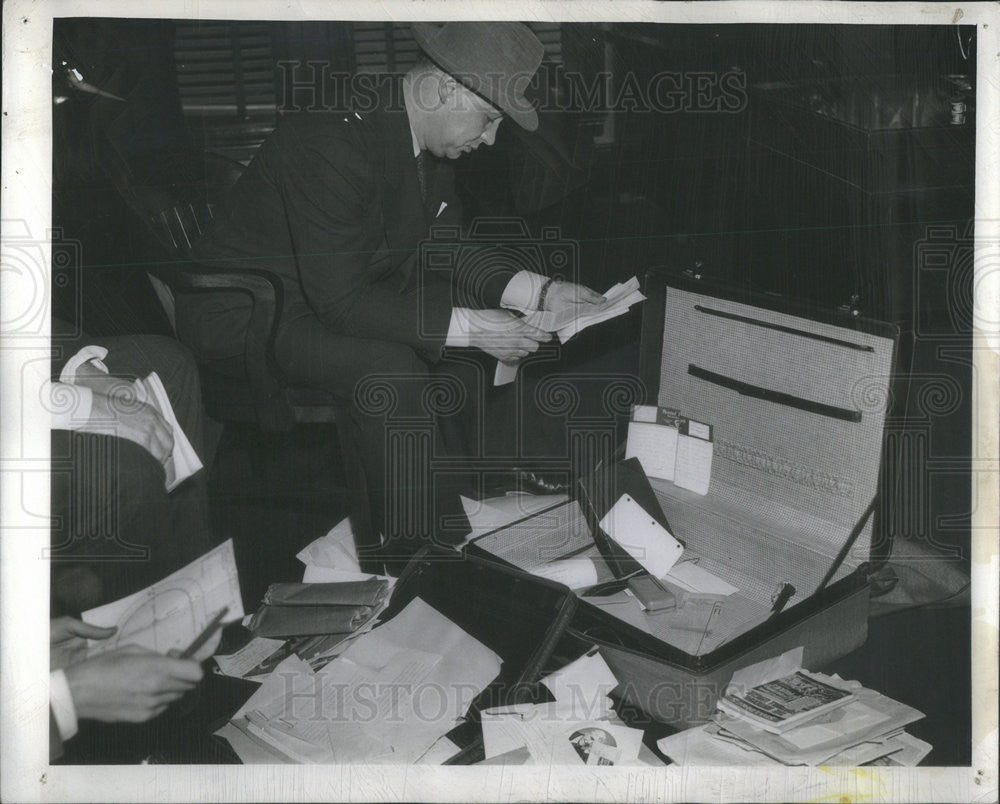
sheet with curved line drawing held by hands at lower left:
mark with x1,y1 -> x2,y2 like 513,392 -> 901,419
83,539 -> 243,661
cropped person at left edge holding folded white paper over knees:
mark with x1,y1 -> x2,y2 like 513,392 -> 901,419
49,320 -> 213,613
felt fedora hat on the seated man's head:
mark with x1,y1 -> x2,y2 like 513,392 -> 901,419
412,22 -> 545,131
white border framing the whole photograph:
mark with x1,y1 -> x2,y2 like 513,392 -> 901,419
0,0 -> 1000,802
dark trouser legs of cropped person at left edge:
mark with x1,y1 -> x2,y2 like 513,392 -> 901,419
51,335 -> 213,609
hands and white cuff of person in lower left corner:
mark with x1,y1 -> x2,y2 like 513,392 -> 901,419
49,617 -> 202,760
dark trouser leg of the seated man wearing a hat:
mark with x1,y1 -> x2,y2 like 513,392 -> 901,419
275,317 -> 468,568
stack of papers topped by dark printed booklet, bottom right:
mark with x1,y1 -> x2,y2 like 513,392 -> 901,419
657,648 -> 931,765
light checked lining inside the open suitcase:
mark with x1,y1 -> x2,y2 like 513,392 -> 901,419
650,288 -> 893,654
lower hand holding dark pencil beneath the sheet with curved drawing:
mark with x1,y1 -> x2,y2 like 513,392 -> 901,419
63,646 -> 202,723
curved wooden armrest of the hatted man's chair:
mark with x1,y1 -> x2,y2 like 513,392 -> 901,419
161,267 -> 295,431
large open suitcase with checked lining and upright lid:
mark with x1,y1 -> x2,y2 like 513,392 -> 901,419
473,271 -> 897,728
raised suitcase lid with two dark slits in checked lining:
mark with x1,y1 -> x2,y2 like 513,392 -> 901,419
641,270 -> 898,557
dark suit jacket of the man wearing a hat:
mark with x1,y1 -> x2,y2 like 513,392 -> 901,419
178,77 -> 514,360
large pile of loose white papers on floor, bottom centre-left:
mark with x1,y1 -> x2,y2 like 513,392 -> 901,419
217,598 -> 500,764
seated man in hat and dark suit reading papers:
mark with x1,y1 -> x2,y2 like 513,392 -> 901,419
177,22 -> 602,569
